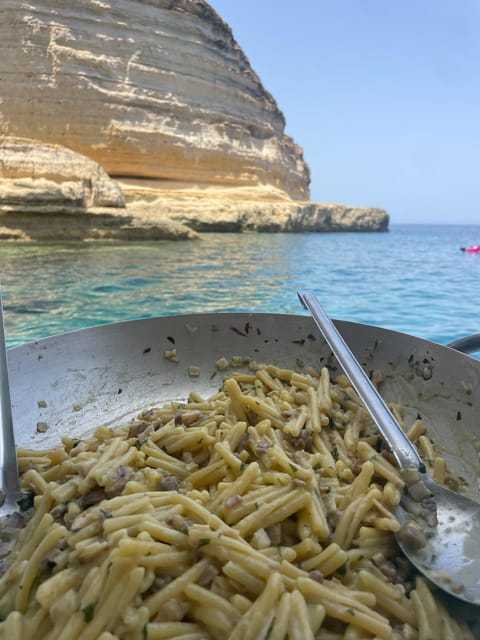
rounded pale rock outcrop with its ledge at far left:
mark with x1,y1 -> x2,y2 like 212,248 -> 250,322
0,138 -> 198,241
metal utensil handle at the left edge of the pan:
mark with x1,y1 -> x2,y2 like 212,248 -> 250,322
0,290 -> 20,503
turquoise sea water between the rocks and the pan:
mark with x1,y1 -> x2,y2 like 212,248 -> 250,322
0,225 -> 480,346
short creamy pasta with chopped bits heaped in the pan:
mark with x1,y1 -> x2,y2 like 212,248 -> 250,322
0,365 -> 473,640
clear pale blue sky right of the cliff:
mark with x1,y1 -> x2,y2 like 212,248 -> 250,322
210,0 -> 480,224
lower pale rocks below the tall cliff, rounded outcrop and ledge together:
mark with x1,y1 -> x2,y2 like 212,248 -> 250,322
0,138 -> 388,242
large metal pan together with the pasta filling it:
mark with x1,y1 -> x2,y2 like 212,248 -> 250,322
0,313 -> 480,640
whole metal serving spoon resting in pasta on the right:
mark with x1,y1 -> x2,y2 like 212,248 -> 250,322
298,291 -> 480,605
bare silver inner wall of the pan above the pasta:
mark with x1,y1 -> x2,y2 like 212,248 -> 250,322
8,313 -> 480,497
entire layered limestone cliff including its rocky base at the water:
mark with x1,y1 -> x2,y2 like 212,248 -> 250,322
0,0 -> 388,239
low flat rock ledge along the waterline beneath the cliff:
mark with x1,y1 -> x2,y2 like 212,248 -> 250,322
0,195 -> 388,242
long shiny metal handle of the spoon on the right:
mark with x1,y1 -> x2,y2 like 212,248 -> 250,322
298,290 -> 423,469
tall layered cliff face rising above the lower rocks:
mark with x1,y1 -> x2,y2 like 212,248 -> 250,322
0,0 -> 309,200
